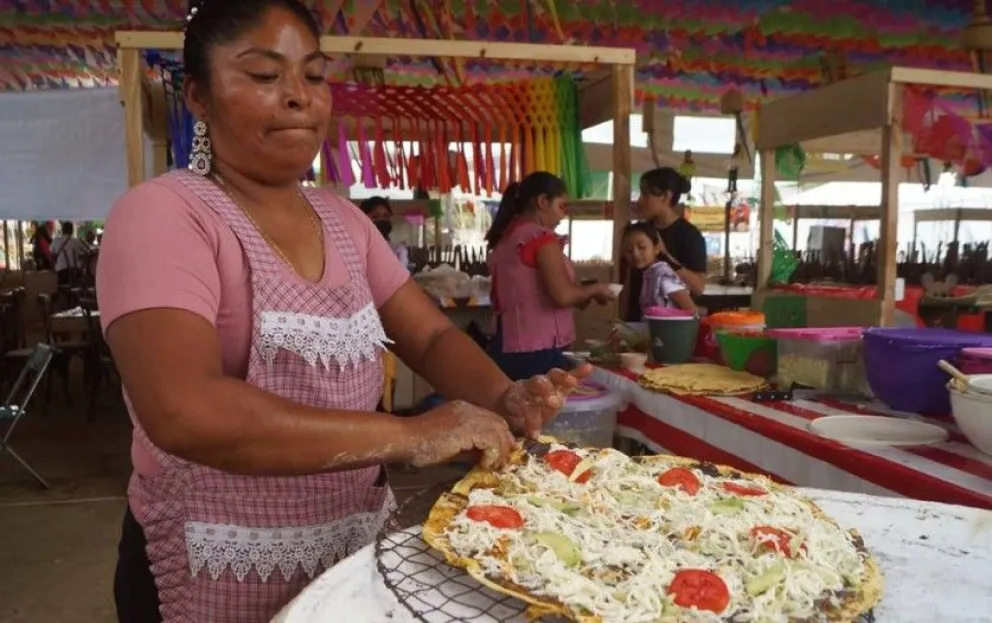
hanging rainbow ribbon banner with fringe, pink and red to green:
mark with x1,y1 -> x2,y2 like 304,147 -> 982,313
324,77 -> 591,197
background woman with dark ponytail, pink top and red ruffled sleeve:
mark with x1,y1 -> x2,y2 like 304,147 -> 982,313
486,171 -> 614,379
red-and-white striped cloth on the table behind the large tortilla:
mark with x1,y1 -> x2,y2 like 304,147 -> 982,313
592,368 -> 992,510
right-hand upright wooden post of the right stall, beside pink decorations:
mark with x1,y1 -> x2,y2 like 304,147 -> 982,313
876,83 -> 903,327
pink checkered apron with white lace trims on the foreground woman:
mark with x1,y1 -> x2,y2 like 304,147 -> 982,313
130,171 -> 394,623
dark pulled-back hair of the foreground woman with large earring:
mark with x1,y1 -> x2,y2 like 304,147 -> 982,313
183,0 -> 320,88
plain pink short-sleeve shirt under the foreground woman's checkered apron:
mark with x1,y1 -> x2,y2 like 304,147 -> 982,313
97,177 -> 410,378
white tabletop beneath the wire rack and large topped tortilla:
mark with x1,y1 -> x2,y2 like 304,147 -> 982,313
273,489 -> 992,623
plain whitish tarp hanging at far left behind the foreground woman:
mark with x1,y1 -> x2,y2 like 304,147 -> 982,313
0,88 -> 148,220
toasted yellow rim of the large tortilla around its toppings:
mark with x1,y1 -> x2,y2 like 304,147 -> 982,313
423,437 -> 882,623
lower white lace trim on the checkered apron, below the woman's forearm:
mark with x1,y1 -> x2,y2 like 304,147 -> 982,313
186,496 -> 395,582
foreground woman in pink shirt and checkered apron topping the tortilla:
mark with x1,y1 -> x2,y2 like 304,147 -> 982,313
98,0 -> 583,623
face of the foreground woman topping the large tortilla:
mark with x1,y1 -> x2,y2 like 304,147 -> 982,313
187,7 -> 331,183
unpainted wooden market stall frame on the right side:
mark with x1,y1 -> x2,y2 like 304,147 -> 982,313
754,67 -> 992,326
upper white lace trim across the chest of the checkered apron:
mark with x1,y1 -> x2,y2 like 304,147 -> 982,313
259,303 -> 392,369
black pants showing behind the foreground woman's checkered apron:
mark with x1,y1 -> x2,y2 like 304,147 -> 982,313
114,508 -> 162,623
